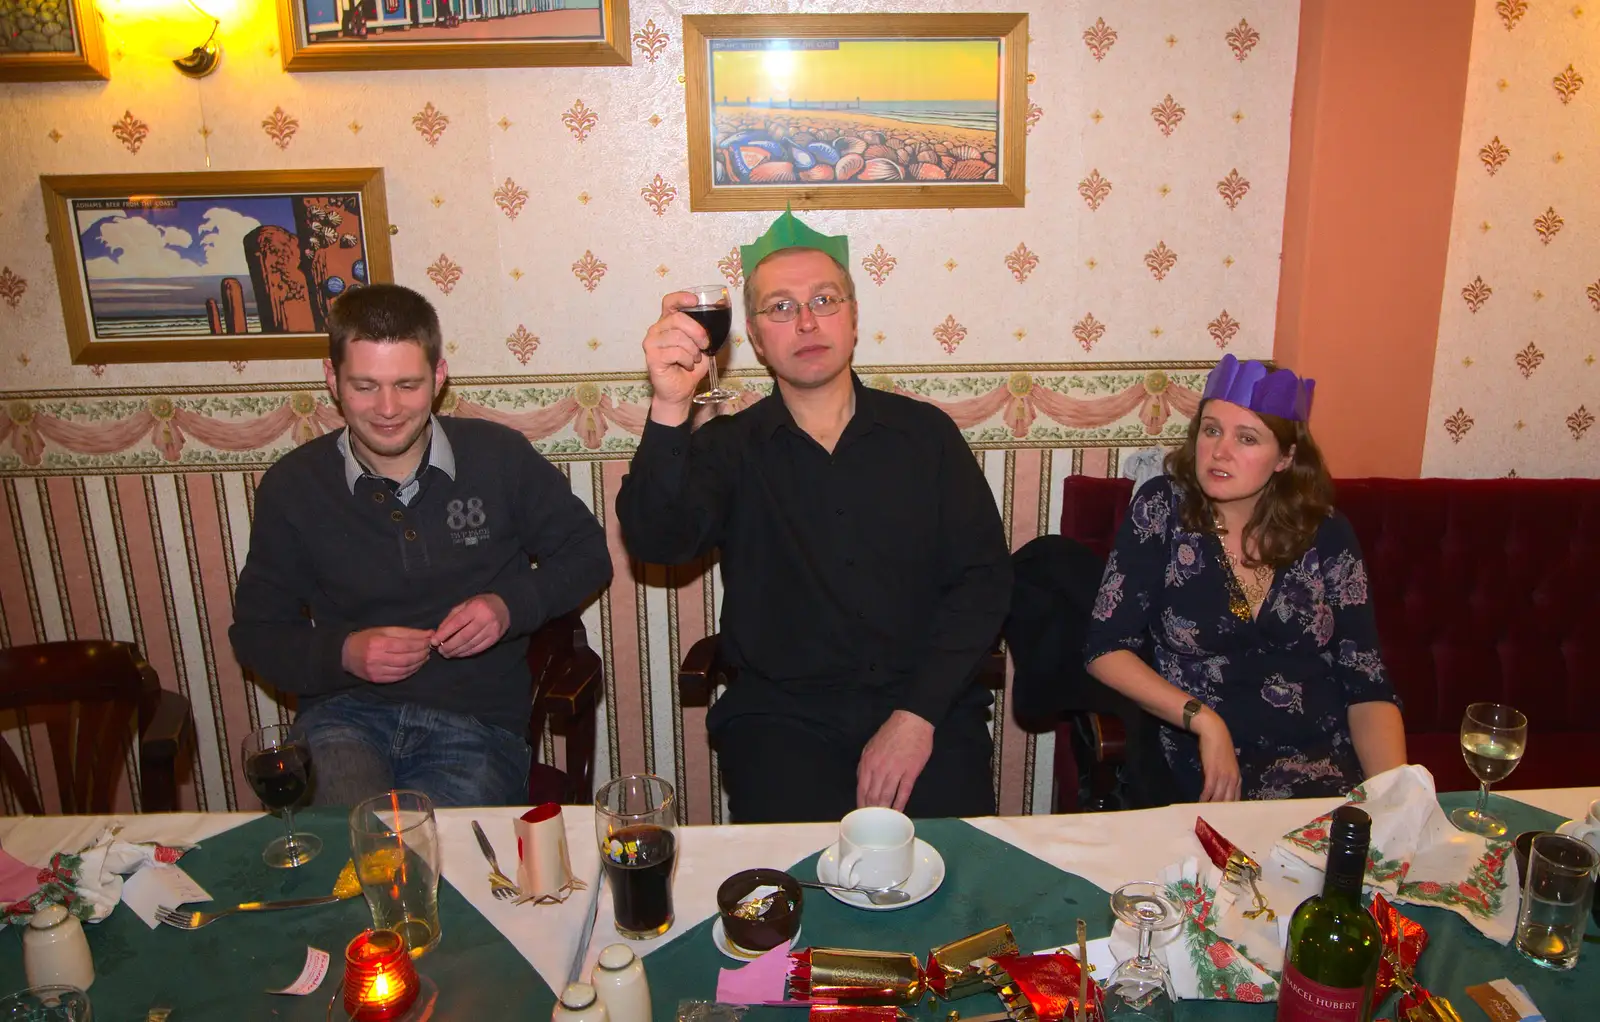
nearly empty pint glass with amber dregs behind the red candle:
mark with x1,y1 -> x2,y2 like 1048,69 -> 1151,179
350,792 -> 440,958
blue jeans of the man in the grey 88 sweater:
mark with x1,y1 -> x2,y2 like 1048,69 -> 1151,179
293,694 -> 533,806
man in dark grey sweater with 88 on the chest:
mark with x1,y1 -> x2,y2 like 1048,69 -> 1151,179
229,285 -> 611,806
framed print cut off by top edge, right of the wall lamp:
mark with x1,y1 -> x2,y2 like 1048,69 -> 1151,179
277,0 -> 632,70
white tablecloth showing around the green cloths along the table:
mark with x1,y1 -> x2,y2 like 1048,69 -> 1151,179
0,787 -> 1600,990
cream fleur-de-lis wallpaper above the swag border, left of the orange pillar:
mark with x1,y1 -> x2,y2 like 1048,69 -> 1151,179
0,0 -> 1298,390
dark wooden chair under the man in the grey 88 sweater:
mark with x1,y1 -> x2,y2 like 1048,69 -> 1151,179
528,611 -> 605,804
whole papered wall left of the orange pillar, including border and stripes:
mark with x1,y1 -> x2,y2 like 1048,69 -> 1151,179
0,0 -> 1298,822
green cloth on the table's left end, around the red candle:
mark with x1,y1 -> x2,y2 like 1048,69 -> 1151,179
0,809 -> 555,1022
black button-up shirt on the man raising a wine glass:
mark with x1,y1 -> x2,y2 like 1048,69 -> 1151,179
616,379 -> 1011,725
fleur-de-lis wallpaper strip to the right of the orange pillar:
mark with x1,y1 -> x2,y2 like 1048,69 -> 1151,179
1422,0 -> 1600,477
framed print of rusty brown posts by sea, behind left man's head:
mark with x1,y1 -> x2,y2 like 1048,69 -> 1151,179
38,168 -> 394,365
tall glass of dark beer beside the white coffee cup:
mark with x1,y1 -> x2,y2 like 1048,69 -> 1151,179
595,774 -> 678,940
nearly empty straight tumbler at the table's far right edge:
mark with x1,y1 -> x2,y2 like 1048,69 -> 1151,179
1514,833 -> 1600,969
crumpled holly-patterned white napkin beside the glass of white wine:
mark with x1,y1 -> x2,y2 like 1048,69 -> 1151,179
1272,765 -> 1522,944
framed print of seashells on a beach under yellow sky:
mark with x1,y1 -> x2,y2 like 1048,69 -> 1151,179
683,14 -> 1027,210
